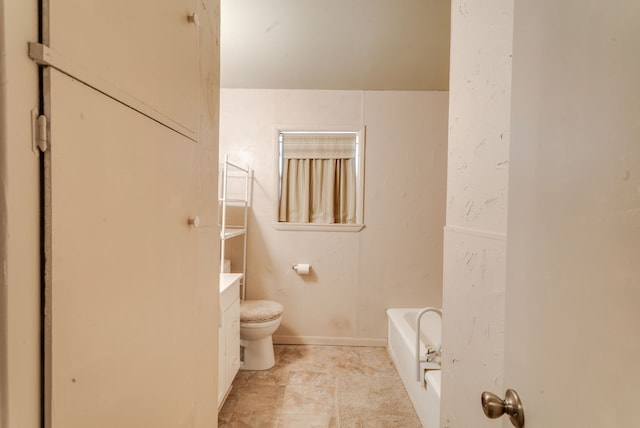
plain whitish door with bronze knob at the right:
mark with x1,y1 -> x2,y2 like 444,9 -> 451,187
500,0 -> 640,428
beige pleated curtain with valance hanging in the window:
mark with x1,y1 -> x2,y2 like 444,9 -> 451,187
279,133 -> 356,224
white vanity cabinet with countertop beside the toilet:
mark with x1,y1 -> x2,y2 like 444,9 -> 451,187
218,273 -> 242,410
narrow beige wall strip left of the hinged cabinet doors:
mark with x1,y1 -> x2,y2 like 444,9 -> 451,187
0,0 -> 40,428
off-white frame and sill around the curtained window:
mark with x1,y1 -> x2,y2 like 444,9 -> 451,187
273,125 -> 366,232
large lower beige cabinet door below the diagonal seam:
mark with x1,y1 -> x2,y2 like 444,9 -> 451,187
45,70 -> 200,428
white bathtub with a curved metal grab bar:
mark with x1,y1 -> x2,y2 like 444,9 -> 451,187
387,308 -> 442,428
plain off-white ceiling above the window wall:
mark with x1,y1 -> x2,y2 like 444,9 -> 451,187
220,0 -> 451,90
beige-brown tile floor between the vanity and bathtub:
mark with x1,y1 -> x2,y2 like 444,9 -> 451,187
218,345 -> 421,428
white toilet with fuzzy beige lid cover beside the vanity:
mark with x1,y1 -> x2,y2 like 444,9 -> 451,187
240,300 -> 284,370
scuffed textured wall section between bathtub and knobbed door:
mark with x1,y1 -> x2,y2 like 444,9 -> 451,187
441,0 -> 513,428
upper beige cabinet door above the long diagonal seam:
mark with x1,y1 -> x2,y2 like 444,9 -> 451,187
44,0 -> 198,134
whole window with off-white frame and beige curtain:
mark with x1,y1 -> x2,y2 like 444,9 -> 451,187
277,129 -> 364,231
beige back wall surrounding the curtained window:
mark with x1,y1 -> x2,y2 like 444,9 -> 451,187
220,89 -> 448,344
